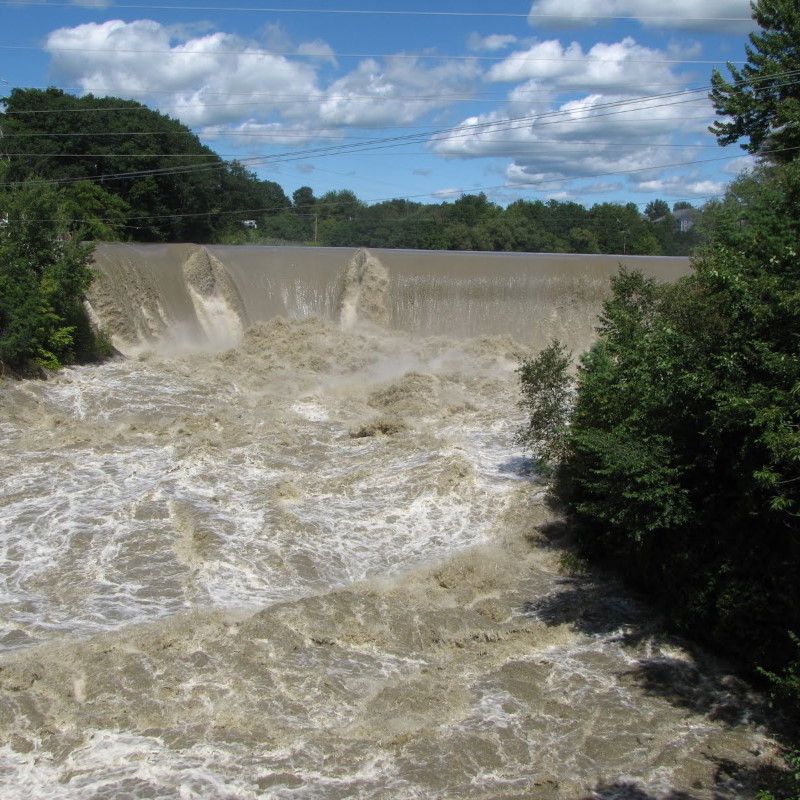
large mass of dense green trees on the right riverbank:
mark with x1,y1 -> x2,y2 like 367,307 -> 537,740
560,163 -> 800,668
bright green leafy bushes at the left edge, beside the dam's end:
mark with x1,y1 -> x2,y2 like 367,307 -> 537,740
0,186 -> 95,371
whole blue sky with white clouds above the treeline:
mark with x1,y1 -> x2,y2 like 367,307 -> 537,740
0,0 -> 764,207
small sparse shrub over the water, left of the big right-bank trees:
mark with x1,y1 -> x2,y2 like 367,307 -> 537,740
516,341 -> 572,465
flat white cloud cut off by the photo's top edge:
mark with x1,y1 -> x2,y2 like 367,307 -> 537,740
528,0 -> 753,33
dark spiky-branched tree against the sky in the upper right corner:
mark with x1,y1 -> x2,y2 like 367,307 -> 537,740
709,0 -> 800,163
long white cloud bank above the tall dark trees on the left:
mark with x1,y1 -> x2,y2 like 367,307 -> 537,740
45,20 -> 481,138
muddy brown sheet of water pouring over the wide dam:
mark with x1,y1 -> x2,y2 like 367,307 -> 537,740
86,244 -> 688,351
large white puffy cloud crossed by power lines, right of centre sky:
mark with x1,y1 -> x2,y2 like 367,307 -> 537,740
429,46 -> 713,200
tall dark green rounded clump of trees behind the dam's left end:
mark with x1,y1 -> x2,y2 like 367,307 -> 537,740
2,88 -> 290,242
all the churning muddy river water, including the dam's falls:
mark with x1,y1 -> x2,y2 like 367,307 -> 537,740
0,245 -> 775,800
